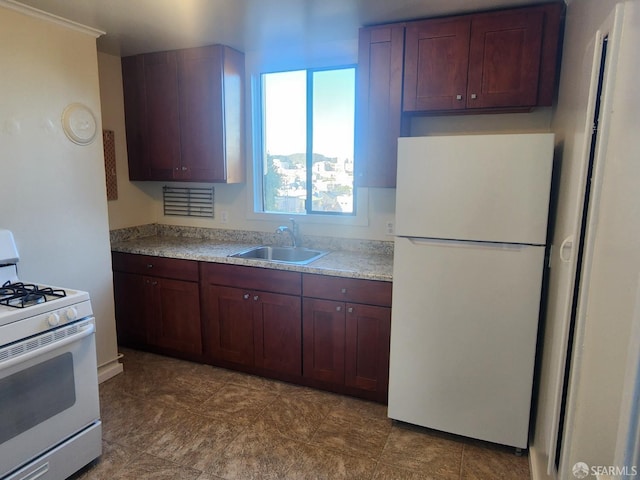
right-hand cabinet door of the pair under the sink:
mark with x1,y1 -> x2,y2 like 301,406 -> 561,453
252,292 -> 302,375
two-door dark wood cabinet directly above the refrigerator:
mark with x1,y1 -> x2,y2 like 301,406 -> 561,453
403,3 -> 563,113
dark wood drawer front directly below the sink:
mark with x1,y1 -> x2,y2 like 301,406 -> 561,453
201,263 -> 301,295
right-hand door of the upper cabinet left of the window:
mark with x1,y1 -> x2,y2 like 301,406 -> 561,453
178,47 -> 225,181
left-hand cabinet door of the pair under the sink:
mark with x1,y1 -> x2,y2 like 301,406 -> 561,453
203,285 -> 254,366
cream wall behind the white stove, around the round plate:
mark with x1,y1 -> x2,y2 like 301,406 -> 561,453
0,4 -> 117,378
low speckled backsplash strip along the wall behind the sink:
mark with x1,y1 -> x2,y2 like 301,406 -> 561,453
110,223 -> 393,255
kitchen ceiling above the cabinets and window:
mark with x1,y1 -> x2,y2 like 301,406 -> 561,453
19,0 -> 560,56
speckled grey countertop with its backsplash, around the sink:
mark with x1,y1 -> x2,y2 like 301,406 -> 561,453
111,225 -> 393,282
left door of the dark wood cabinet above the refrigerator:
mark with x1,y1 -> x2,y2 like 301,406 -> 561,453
403,16 -> 471,112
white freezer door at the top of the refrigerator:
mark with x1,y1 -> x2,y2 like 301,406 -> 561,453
396,134 -> 553,245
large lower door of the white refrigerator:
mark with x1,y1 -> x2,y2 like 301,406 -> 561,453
388,237 -> 544,448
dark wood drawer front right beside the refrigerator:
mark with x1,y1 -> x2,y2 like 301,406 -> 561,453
302,274 -> 391,306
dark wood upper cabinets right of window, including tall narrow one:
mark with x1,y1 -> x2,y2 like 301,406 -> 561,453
355,2 -> 564,187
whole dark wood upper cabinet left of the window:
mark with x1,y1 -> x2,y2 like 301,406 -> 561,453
122,45 -> 244,183
